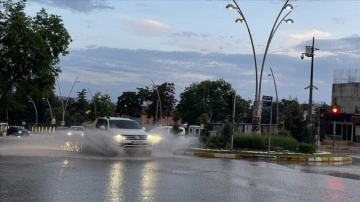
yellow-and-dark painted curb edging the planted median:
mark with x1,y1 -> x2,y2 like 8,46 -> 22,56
174,150 -> 352,163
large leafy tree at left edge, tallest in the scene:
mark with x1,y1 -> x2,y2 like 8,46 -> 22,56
0,0 -> 71,117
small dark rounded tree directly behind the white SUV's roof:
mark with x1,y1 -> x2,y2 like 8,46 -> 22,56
116,92 -> 141,118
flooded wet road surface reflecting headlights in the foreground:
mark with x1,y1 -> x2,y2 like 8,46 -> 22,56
0,134 -> 360,202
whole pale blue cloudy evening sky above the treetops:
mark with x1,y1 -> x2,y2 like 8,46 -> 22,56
26,0 -> 360,103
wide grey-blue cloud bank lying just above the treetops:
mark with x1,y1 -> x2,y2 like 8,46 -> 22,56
59,34 -> 360,103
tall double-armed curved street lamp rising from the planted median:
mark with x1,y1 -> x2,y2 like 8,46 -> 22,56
226,0 -> 294,133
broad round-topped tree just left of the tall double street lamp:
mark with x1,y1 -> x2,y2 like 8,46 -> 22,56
177,79 -> 249,125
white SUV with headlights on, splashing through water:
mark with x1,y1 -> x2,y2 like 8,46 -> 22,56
95,117 -> 152,153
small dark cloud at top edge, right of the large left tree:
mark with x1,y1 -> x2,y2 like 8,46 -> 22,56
31,0 -> 114,13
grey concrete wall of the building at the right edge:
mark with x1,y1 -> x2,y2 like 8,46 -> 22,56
332,83 -> 360,114
